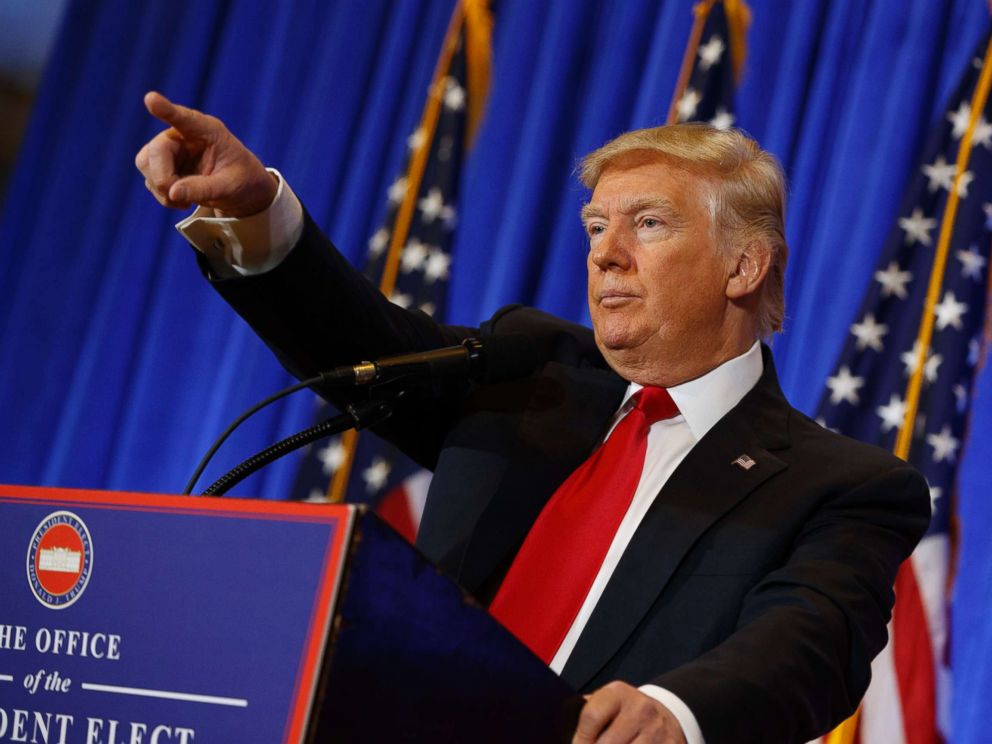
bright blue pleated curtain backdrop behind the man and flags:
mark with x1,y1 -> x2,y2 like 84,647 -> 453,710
0,0 -> 992,742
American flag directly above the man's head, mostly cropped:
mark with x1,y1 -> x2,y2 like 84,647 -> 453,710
668,0 -> 751,129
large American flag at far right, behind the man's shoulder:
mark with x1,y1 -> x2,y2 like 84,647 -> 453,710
819,30 -> 992,744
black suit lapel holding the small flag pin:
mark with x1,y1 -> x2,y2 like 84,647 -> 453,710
562,350 -> 791,689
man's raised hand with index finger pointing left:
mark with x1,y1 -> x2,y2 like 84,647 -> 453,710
134,92 -> 278,217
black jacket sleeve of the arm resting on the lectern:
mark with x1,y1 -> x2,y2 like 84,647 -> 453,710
654,460 -> 929,744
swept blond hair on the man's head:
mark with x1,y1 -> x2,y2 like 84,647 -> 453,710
579,122 -> 789,338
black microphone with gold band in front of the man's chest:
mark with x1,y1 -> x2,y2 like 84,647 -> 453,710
320,333 -> 541,385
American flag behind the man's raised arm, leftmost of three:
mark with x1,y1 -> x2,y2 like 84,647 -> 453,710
293,2 -> 485,541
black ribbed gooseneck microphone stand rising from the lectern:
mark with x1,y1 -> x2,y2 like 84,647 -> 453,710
202,390 -> 403,496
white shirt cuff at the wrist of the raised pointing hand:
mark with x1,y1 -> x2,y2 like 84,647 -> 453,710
176,168 -> 303,279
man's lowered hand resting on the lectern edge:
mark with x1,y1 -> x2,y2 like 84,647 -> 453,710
572,682 -> 685,744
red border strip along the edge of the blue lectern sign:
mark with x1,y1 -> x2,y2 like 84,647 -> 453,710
0,485 -> 354,742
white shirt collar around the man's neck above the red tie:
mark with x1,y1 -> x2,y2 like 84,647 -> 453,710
620,341 -> 764,442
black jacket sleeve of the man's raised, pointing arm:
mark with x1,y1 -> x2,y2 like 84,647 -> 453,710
197,206 -> 478,469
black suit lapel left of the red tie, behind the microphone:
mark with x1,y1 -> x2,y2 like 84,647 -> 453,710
458,363 -> 627,602
